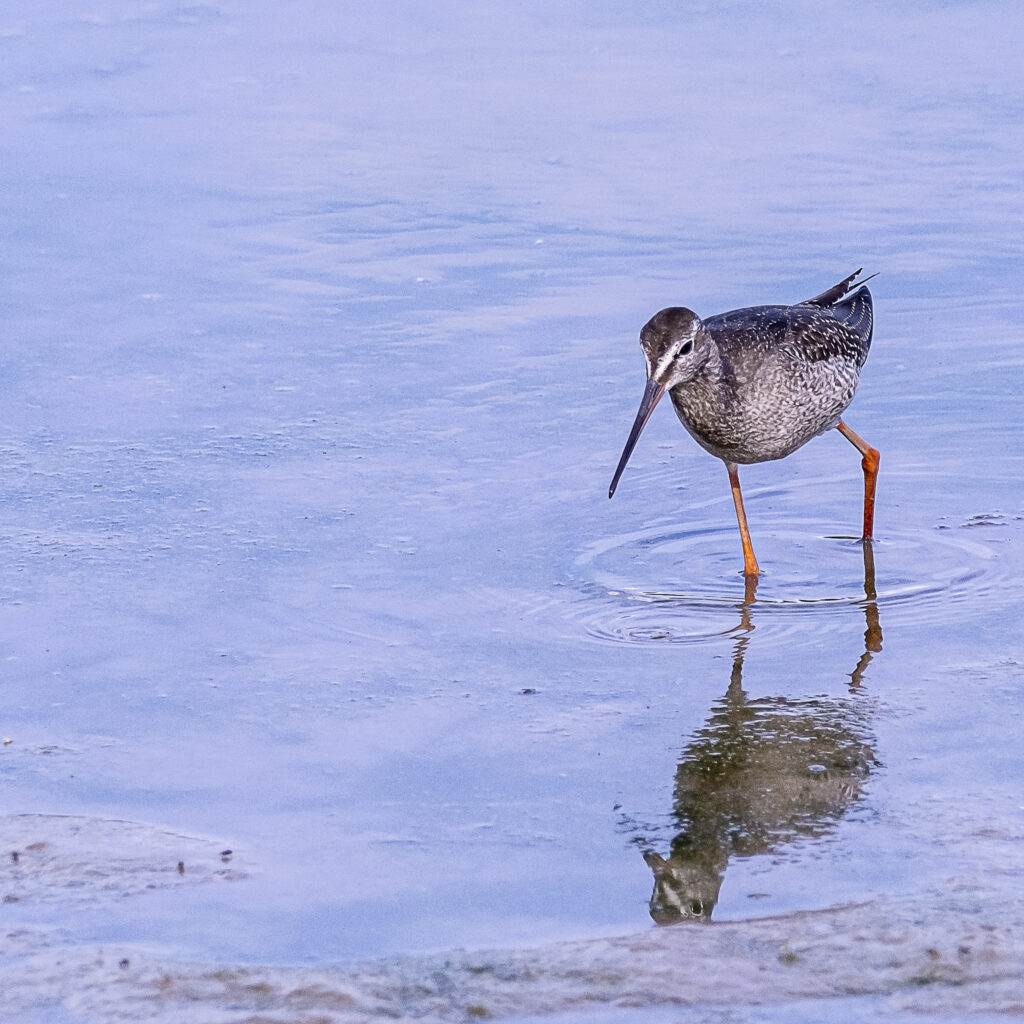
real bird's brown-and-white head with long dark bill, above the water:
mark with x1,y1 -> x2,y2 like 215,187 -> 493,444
608,306 -> 714,498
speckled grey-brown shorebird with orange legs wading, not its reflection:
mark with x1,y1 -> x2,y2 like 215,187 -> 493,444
608,270 -> 879,580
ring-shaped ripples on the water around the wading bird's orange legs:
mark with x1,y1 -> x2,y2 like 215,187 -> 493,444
572,519 -> 997,644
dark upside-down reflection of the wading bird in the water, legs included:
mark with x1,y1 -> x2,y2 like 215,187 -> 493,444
640,542 -> 882,925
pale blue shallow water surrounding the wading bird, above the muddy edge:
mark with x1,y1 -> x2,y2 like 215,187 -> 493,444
0,0 -> 1024,1022
